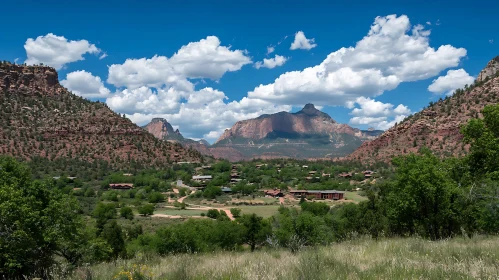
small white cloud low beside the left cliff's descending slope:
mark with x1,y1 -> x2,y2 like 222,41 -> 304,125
61,70 -> 110,98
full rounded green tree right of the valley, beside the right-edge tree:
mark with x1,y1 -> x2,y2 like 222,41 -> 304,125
387,149 -> 460,239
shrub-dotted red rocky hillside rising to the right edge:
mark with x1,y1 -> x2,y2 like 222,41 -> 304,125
346,56 -> 499,162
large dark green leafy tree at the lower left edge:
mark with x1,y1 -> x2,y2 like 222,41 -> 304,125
0,157 -> 83,279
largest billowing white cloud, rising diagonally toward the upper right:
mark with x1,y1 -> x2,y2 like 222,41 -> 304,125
248,15 -> 466,107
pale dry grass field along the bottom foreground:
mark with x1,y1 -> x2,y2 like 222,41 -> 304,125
64,236 -> 499,280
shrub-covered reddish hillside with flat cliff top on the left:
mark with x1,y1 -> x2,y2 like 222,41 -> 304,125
0,63 -> 200,168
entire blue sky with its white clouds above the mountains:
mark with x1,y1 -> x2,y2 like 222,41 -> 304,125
0,0 -> 499,141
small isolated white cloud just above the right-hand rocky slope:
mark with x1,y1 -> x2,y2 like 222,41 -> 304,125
428,69 -> 475,95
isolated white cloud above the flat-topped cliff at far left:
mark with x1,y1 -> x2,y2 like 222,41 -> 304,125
24,33 -> 101,70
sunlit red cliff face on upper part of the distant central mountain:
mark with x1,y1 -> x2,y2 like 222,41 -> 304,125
217,104 -> 362,143
